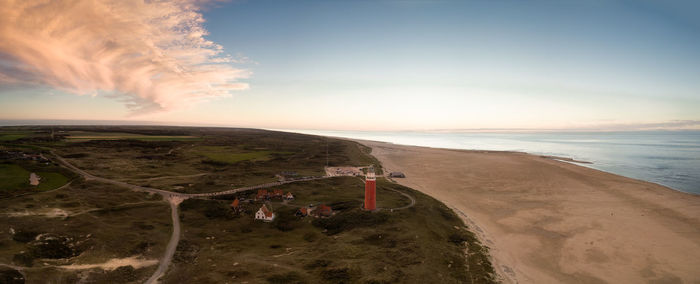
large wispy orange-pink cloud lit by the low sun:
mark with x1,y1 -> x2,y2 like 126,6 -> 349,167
0,0 -> 250,113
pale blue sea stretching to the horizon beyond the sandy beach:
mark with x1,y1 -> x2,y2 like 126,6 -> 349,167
283,129 -> 700,194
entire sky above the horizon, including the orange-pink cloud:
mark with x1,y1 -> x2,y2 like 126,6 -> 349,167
0,0 -> 700,130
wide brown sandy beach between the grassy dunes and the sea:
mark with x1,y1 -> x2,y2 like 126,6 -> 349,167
358,141 -> 700,283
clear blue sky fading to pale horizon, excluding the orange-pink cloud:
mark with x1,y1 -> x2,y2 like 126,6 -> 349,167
0,1 -> 700,130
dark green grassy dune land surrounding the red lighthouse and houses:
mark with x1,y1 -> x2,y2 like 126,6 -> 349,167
0,126 -> 495,283
